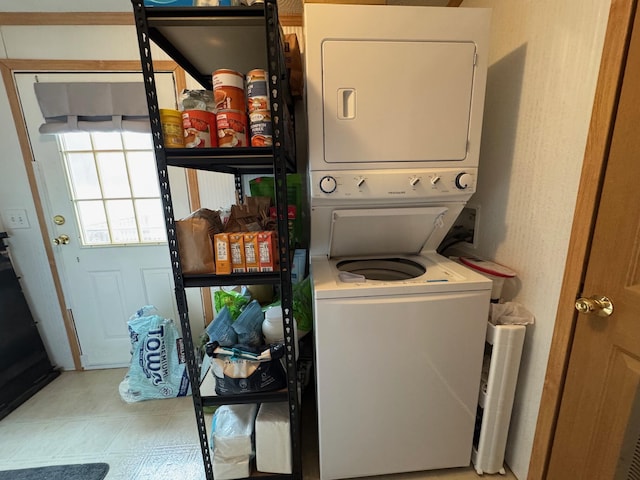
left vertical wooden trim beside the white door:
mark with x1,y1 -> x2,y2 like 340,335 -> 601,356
0,62 -> 82,370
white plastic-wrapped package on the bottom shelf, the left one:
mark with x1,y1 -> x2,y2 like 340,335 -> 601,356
211,403 -> 258,458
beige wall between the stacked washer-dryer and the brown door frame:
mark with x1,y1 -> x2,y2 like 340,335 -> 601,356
462,0 -> 610,480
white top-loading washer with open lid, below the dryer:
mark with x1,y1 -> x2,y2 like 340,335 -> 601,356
311,191 -> 492,480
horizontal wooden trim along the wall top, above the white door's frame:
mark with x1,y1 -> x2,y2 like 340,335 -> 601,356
0,12 -> 302,27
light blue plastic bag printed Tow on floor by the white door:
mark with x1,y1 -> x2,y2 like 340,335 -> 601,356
119,305 -> 191,403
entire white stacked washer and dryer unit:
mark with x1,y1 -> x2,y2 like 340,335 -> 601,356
304,3 -> 491,480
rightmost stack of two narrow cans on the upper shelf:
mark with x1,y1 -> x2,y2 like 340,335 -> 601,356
247,69 -> 273,147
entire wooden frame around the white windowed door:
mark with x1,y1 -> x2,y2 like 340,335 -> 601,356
0,59 -> 188,370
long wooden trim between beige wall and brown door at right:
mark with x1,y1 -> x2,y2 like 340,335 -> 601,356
527,0 -> 636,480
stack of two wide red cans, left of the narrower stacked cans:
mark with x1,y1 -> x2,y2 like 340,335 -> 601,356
213,69 -> 249,147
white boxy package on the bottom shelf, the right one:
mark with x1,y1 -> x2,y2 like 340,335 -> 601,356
256,402 -> 291,472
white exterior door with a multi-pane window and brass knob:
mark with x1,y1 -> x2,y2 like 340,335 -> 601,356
16,73 -> 202,369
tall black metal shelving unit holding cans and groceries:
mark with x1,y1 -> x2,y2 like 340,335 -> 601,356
132,0 -> 302,480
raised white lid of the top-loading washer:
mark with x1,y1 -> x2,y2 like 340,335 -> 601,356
329,207 -> 449,258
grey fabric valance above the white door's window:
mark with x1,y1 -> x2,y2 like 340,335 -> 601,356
34,82 -> 151,134
